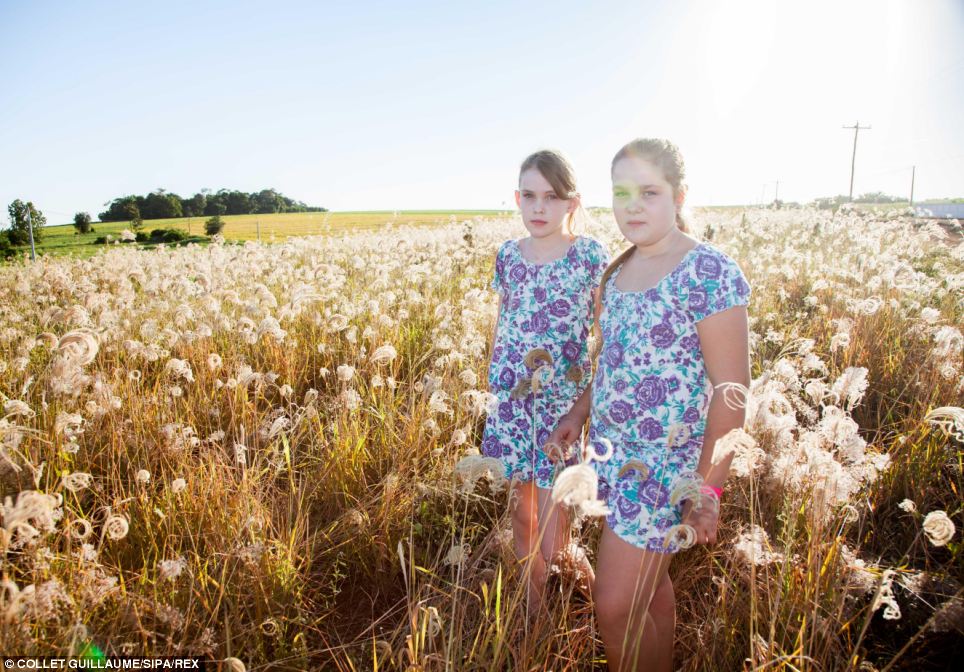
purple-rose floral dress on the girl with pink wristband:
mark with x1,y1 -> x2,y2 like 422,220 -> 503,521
590,243 -> 750,553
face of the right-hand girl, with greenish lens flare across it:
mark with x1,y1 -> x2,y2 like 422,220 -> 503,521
613,157 -> 684,247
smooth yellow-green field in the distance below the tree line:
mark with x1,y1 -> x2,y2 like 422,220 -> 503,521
7,210 -> 500,257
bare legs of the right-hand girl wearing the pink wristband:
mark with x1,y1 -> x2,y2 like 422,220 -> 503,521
593,526 -> 675,672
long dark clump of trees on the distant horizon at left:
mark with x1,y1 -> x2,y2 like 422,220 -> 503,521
98,189 -> 327,222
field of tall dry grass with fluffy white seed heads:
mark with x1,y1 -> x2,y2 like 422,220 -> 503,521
0,210 -> 964,672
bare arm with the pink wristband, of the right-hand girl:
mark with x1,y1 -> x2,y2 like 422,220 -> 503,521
696,306 -> 750,487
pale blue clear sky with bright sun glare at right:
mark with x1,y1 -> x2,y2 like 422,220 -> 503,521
0,0 -> 964,224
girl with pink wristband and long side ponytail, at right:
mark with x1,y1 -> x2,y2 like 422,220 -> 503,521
552,139 -> 750,670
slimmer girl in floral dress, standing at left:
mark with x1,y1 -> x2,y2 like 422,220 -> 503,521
482,150 -> 609,613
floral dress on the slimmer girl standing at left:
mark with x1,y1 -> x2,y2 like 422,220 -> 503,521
482,236 -> 609,488
